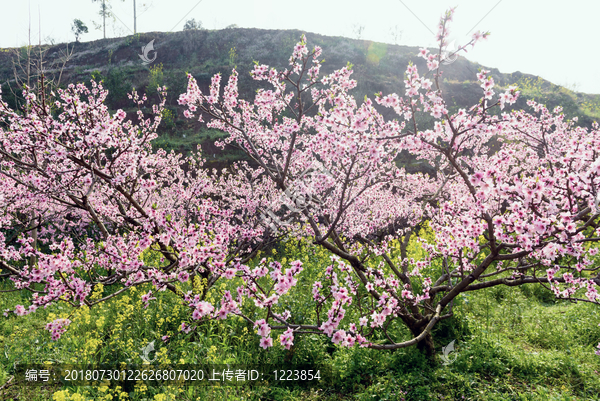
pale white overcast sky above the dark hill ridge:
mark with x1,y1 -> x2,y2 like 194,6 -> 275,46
0,0 -> 600,94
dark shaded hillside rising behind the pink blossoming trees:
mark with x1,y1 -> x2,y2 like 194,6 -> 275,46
0,28 -> 600,166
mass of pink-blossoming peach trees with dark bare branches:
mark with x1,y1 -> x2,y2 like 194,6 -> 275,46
0,10 -> 600,349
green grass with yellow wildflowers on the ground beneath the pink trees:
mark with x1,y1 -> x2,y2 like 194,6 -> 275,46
0,239 -> 600,401
